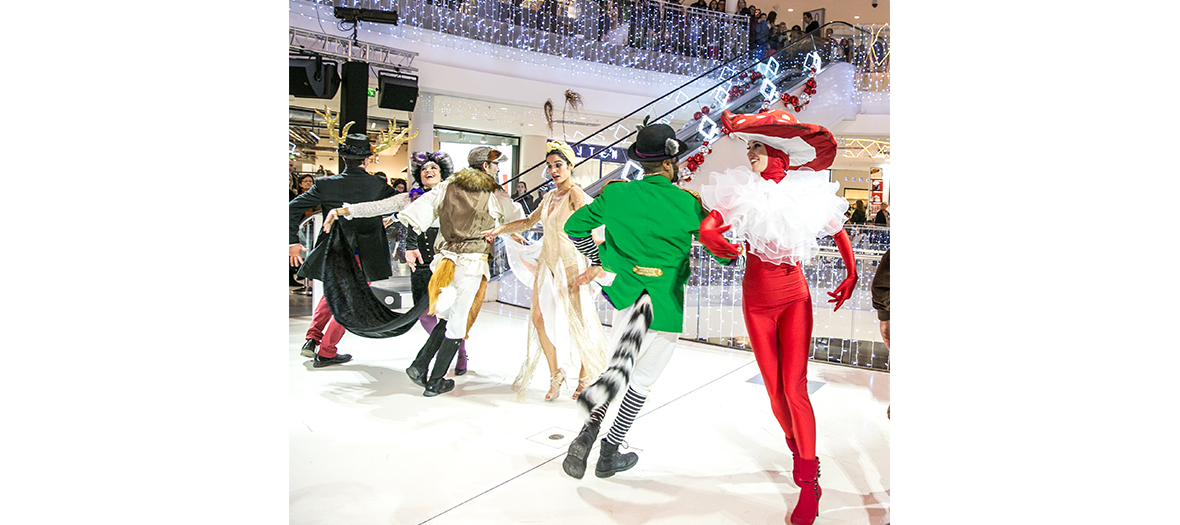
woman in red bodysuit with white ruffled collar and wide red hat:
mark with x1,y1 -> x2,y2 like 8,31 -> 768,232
700,111 -> 857,525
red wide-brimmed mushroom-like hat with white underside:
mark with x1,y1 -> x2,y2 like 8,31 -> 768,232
721,110 -> 837,171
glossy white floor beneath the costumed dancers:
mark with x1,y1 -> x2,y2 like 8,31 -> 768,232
288,303 -> 890,525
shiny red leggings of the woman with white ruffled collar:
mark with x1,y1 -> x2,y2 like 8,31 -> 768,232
742,254 -> 815,459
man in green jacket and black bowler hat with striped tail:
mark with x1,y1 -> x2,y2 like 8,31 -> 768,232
554,119 -> 732,479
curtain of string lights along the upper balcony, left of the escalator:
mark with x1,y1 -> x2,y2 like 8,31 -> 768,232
314,0 -> 749,76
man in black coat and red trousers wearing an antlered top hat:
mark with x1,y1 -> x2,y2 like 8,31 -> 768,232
288,133 -> 394,368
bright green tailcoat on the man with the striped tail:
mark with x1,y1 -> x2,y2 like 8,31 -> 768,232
565,175 -> 729,333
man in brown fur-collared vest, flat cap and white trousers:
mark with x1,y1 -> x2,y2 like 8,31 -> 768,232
398,146 -> 524,398
